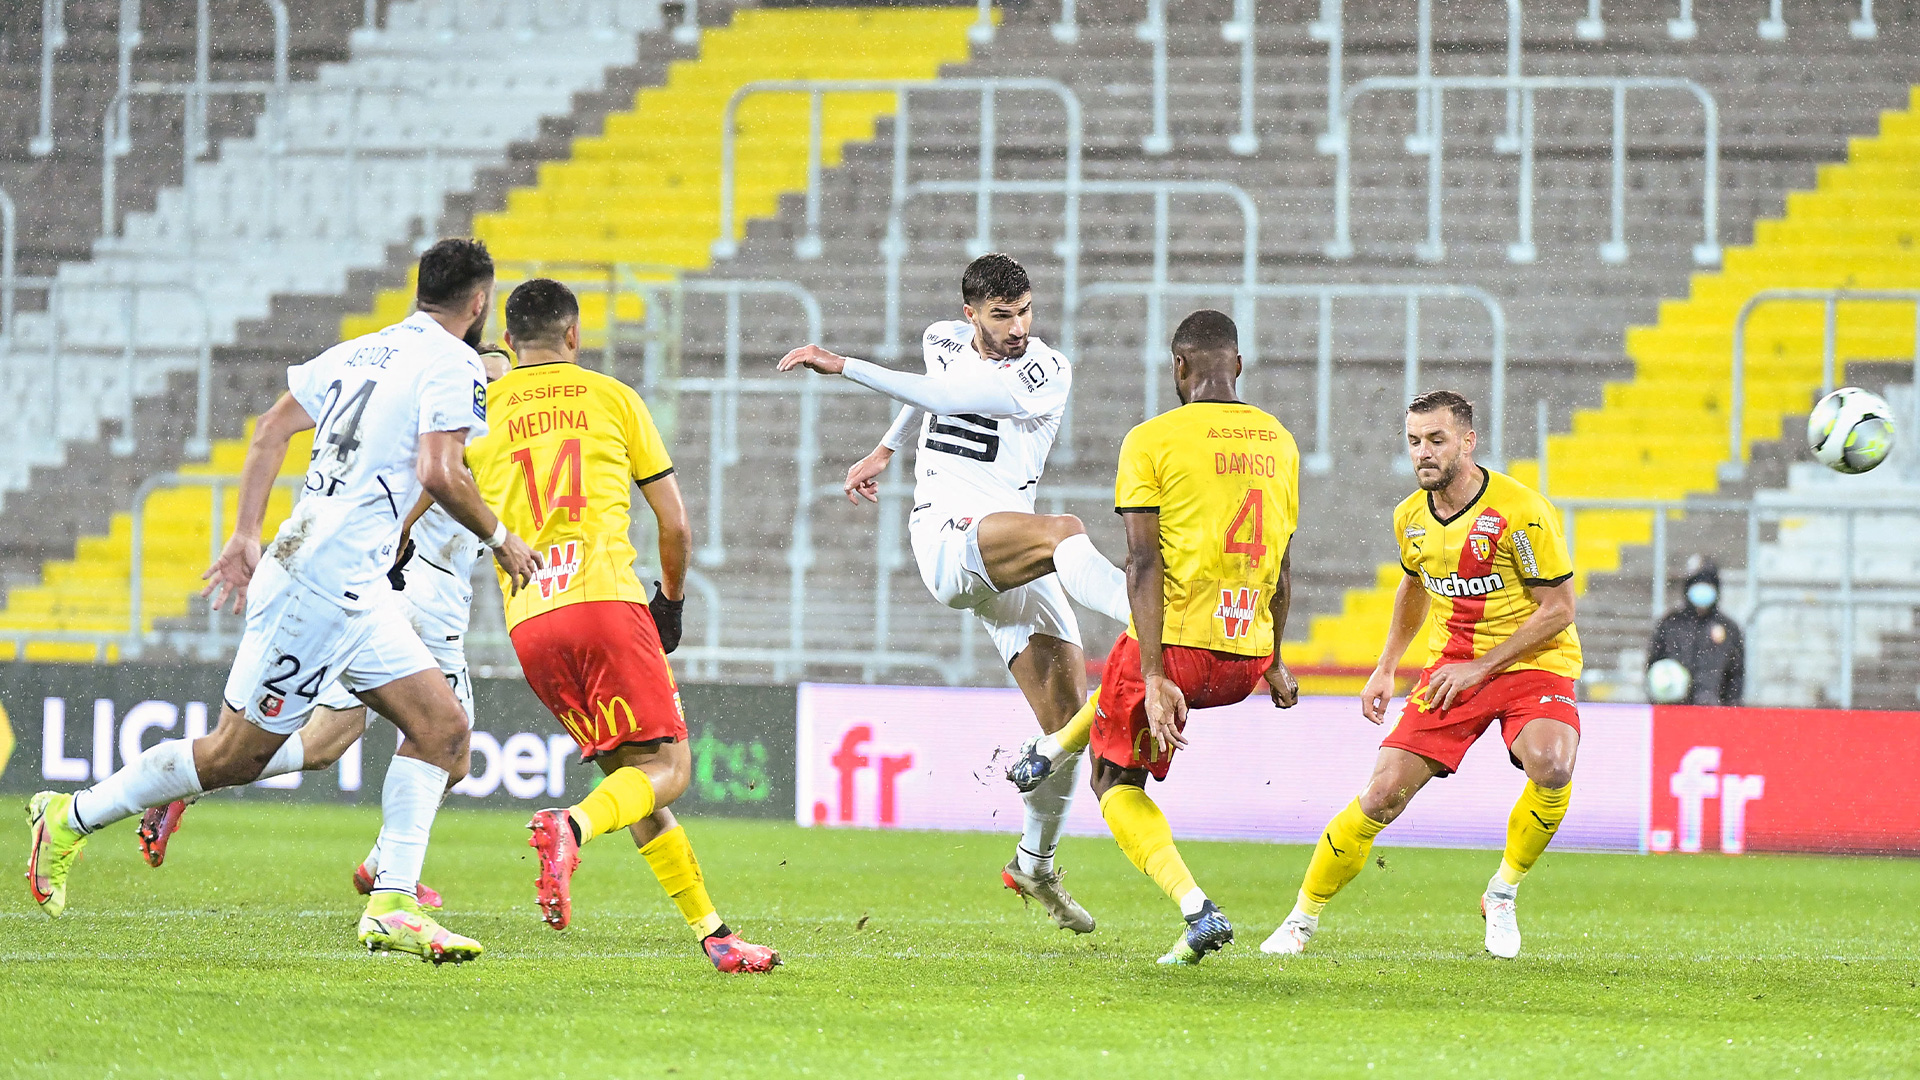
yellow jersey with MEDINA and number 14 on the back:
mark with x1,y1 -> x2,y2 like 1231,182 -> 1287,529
467,363 -> 674,630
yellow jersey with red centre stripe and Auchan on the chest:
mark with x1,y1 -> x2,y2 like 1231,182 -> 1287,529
1394,469 -> 1580,678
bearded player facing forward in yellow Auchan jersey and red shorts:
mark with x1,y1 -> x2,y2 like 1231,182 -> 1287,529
1261,390 -> 1580,959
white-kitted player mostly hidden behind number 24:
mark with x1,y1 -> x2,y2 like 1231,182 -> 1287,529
136,344 -> 513,907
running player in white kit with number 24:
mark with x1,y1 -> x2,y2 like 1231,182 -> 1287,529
27,240 -> 540,963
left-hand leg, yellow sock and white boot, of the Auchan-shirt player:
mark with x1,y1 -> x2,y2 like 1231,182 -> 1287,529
1260,746 -> 1440,955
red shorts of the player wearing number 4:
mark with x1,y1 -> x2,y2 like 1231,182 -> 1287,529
1091,634 -> 1273,780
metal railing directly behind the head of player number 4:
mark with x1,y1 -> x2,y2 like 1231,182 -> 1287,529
1083,279 -> 1507,473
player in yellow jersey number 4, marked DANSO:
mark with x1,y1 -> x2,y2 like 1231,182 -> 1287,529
1091,311 -> 1300,965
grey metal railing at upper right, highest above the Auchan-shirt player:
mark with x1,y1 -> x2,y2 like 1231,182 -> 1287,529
1327,75 -> 1720,265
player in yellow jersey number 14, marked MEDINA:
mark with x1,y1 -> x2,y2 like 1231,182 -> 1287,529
467,279 -> 780,972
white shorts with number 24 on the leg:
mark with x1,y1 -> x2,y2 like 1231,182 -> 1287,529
225,559 -> 434,734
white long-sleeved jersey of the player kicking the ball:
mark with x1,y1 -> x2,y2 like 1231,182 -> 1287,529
914,319 -> 1073,513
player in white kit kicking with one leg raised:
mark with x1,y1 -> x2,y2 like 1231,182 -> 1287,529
780,254 -> 1129,934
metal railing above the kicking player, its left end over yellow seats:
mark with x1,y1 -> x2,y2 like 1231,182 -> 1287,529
712,79 -> 1081,259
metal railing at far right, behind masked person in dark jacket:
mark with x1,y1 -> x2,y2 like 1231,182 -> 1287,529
1542,495 -> 1920,709
